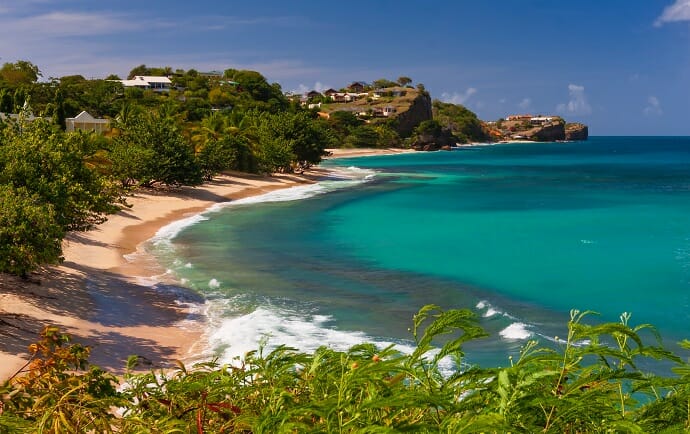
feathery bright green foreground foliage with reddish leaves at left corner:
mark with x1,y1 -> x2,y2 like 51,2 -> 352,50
0,306 -> 690,433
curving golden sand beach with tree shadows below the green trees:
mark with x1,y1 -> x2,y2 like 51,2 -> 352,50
0,168 -> 325,381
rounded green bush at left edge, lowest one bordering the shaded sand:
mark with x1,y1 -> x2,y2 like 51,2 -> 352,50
0,185 -> 65,277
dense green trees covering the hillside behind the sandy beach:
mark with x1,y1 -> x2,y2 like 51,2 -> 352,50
0,64 -> 460,276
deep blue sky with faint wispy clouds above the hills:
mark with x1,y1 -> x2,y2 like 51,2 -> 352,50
0,0 -> 690,135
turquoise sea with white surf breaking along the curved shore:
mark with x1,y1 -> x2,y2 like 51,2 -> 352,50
140,137 -> 690,366
